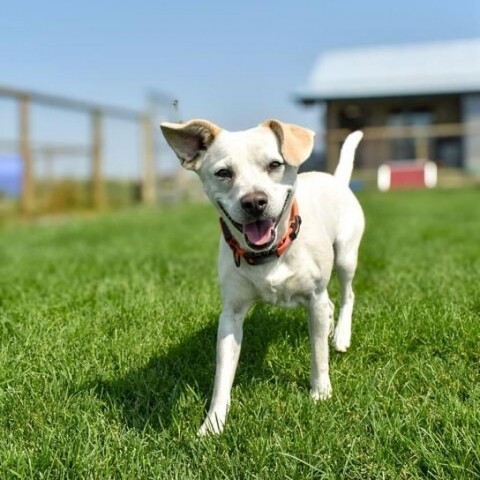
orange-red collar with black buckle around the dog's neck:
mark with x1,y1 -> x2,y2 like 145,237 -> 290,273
220,199 -> 302,267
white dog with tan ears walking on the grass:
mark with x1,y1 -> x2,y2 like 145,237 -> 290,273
161,120 -> 364,434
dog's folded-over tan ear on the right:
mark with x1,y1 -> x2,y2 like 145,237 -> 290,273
261,119 -> 315,167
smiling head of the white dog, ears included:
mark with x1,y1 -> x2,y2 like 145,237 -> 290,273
161,120 -> 314,251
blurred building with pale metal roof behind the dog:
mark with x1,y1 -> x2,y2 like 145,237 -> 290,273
296,38 -> 480,173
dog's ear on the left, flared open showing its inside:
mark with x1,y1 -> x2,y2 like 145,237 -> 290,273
160,120 -> 221,170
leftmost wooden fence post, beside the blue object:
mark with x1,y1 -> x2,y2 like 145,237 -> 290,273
19,95 -> 35,214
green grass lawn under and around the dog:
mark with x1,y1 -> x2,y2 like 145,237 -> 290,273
0,190 -> 480,479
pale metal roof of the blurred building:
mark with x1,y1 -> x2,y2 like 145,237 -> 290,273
296,38 -> 480,102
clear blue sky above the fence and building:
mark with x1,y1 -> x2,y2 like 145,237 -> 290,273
0,0 -> 480,176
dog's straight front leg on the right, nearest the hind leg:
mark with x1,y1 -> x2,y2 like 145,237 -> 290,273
308,289 -> 333,400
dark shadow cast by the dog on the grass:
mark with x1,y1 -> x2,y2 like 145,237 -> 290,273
89,305 -> 308,430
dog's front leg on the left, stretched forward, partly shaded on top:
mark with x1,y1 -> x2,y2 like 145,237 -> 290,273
199,303 -> 250,435
